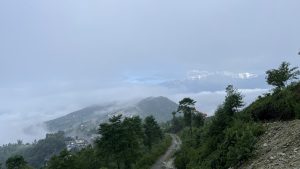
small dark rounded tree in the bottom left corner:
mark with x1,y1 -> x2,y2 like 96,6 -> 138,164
6,155 -> 30,169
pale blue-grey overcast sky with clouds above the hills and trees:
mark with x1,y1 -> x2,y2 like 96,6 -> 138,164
0,0 -> 300,144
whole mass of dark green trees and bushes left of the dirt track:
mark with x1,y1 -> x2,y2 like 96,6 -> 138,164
45,115 -> 165,169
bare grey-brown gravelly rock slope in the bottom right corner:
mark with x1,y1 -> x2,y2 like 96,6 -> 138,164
239,120 -> 300,169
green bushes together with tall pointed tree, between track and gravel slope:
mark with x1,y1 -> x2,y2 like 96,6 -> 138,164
175,85 -> 262,169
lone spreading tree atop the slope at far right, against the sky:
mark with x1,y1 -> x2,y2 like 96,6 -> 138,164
266,62 -> 300,89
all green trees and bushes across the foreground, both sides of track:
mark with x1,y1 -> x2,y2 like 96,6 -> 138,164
0,62 -> 300,169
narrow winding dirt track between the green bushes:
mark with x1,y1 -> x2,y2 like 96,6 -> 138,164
150,134 -> 181,169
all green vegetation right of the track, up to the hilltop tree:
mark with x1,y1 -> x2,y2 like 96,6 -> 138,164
170,62 -> 300,169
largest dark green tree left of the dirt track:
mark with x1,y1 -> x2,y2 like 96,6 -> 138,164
97,115 -> 143,169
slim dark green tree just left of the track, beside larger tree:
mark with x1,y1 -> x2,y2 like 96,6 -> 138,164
144,116 -> 163,150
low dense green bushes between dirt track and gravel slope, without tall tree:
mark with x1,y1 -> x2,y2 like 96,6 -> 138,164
174,118 -> 264,169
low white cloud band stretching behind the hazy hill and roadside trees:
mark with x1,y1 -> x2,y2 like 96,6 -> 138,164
0,80 -> 268,144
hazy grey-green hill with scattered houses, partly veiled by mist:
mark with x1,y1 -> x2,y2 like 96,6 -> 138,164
45,97 -> 178,136
